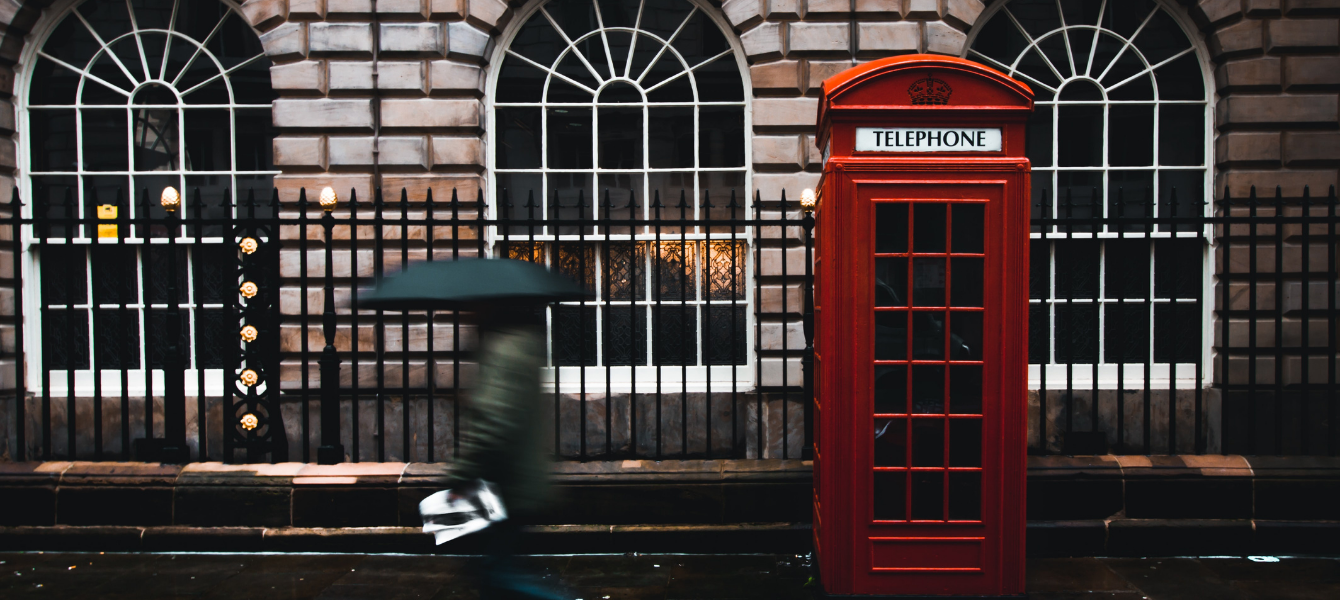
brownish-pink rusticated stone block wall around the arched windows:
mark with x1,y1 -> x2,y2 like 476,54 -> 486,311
0,0 -> 1340,458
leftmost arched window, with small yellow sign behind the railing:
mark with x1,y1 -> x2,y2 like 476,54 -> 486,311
19,0 -> 276,380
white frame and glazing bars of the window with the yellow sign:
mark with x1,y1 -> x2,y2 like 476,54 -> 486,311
13,0 -> 280,396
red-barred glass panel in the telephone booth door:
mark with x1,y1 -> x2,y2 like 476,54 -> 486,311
871,201 -> 988,521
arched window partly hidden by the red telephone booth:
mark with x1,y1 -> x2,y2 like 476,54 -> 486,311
967,0 -> 1210,380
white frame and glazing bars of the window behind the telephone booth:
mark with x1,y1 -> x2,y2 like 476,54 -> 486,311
963,0 -> 1218,390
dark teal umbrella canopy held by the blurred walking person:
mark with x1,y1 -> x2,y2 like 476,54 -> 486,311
358,258 -> 591,311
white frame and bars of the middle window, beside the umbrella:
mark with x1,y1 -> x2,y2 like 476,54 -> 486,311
484,0 -> 758,392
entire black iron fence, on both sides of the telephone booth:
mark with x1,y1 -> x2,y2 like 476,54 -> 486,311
0,183 -> 1340,462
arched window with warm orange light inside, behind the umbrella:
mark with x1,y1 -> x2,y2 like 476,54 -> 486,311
490,0 -> 749,376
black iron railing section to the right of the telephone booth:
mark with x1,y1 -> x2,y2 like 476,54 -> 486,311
1029,182 -> 1340,455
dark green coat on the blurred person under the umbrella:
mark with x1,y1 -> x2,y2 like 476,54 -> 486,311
450,325 -> 549,514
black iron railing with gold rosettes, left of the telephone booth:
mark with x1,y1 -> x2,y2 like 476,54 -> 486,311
0,190 -> 812,463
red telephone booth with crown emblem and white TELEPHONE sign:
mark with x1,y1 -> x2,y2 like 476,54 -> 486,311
815,55 -> 1033,596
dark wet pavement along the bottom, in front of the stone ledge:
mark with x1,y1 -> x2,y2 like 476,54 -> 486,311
0,552 -> 1340,600
